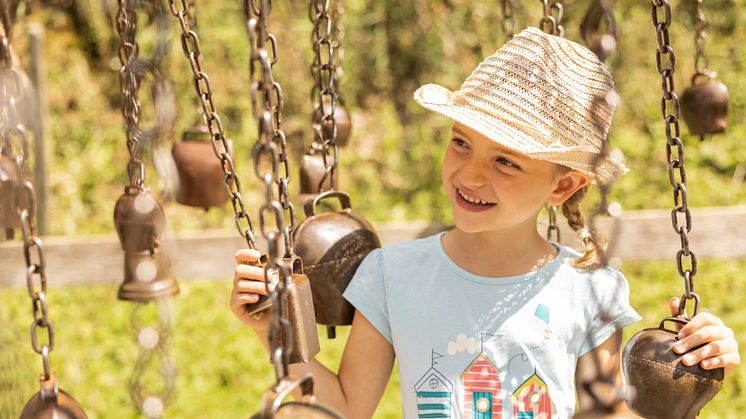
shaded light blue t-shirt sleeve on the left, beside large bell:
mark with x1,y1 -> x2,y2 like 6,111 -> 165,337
343,249 -> 393,344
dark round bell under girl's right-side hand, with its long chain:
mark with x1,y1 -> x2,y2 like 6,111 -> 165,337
623,0 -> 725,419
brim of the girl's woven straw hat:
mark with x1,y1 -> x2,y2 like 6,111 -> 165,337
414,84 -> 628,184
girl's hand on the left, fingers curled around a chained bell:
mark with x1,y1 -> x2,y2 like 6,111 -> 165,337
231,249 -> 274,332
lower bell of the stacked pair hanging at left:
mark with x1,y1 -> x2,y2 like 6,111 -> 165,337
117,251 -> 179,303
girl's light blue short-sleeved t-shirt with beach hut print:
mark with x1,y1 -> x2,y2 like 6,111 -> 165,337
344,234 -> 640,419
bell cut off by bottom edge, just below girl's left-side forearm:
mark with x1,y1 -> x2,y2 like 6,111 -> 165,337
251,375 -> 343,419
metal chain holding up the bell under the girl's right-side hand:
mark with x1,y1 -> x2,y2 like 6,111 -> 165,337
651,0 -> 697,307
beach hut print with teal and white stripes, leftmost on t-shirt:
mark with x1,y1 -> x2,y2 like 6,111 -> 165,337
414,351 -> 453,418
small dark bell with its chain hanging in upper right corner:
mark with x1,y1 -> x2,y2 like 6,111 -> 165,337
681,0 -> 729,140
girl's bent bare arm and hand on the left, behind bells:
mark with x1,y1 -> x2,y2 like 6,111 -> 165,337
231,250 -> 394,419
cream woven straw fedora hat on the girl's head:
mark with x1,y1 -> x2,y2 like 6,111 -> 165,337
414,28 -> 627,184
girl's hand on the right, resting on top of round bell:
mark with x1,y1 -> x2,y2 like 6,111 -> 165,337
669,297 -> 741,374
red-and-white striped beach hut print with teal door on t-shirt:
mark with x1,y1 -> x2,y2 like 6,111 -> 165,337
461,352 -> 503,419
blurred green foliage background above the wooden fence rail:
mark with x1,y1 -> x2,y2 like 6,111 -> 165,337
0,0 -> 746,238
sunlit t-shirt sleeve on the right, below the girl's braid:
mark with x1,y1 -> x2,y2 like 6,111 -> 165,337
578,269 -> 641,356
